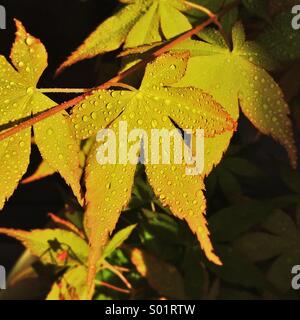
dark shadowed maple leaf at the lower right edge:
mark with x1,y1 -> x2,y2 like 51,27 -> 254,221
234,210 -> 300,293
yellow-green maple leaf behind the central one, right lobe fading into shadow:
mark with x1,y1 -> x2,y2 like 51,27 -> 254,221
175,23 -> 297,172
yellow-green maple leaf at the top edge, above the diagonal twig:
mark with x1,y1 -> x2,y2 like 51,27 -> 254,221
58,0 -> 191,72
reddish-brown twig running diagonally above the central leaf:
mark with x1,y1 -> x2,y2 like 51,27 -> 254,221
0,0 -> 240,141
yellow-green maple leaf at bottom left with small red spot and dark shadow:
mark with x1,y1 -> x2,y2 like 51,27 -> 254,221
0,222 -> 136,300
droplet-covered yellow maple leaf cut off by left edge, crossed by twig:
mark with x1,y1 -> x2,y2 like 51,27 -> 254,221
0,21 -> 81,209
